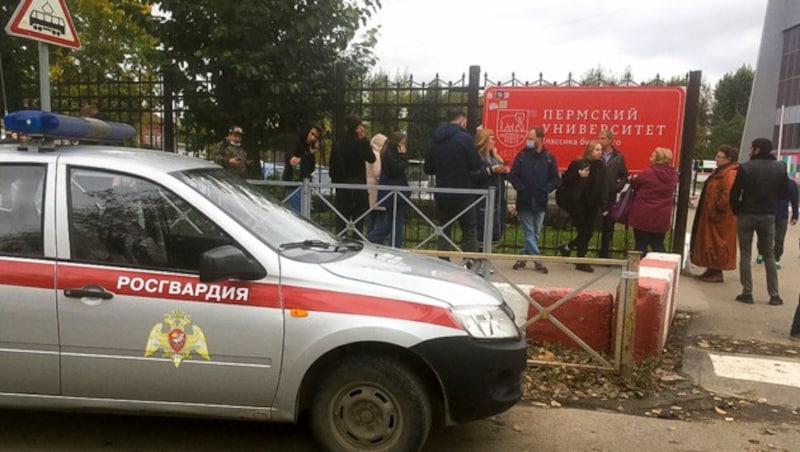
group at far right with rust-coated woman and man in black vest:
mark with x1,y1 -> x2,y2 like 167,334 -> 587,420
690,138 -> 800,308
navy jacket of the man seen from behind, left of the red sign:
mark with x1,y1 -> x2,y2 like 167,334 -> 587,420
423,123 -> 491,199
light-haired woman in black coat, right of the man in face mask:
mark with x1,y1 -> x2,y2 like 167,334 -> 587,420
556,141 -> 608,272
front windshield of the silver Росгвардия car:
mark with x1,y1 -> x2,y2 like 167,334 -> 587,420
175,169 -> 340,249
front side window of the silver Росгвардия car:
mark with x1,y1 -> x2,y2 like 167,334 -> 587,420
69,168 -> 233,271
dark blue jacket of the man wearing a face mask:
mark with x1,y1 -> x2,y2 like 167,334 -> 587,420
508,146 -> 561,213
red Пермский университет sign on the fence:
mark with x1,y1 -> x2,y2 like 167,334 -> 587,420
483,86 -> 686,173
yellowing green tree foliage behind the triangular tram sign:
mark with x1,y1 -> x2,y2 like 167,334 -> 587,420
0,0 -> 161,139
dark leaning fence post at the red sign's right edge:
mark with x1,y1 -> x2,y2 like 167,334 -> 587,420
672,71 -> 703,254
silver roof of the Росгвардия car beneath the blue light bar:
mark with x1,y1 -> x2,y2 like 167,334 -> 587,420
0,143 -> 217,173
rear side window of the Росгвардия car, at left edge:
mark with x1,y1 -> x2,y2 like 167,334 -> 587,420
0,165 -> 47,257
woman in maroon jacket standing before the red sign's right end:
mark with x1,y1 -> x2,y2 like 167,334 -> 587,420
628,148 -> 678,256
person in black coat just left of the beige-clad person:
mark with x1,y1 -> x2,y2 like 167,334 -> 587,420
330,115 -> 375,235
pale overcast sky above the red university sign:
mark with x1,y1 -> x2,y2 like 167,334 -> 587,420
371,0 -> 767,88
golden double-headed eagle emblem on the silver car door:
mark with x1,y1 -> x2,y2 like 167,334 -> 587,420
144,309 -> 211,367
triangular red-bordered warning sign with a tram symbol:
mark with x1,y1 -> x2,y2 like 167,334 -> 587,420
6,0 -> 81,49
